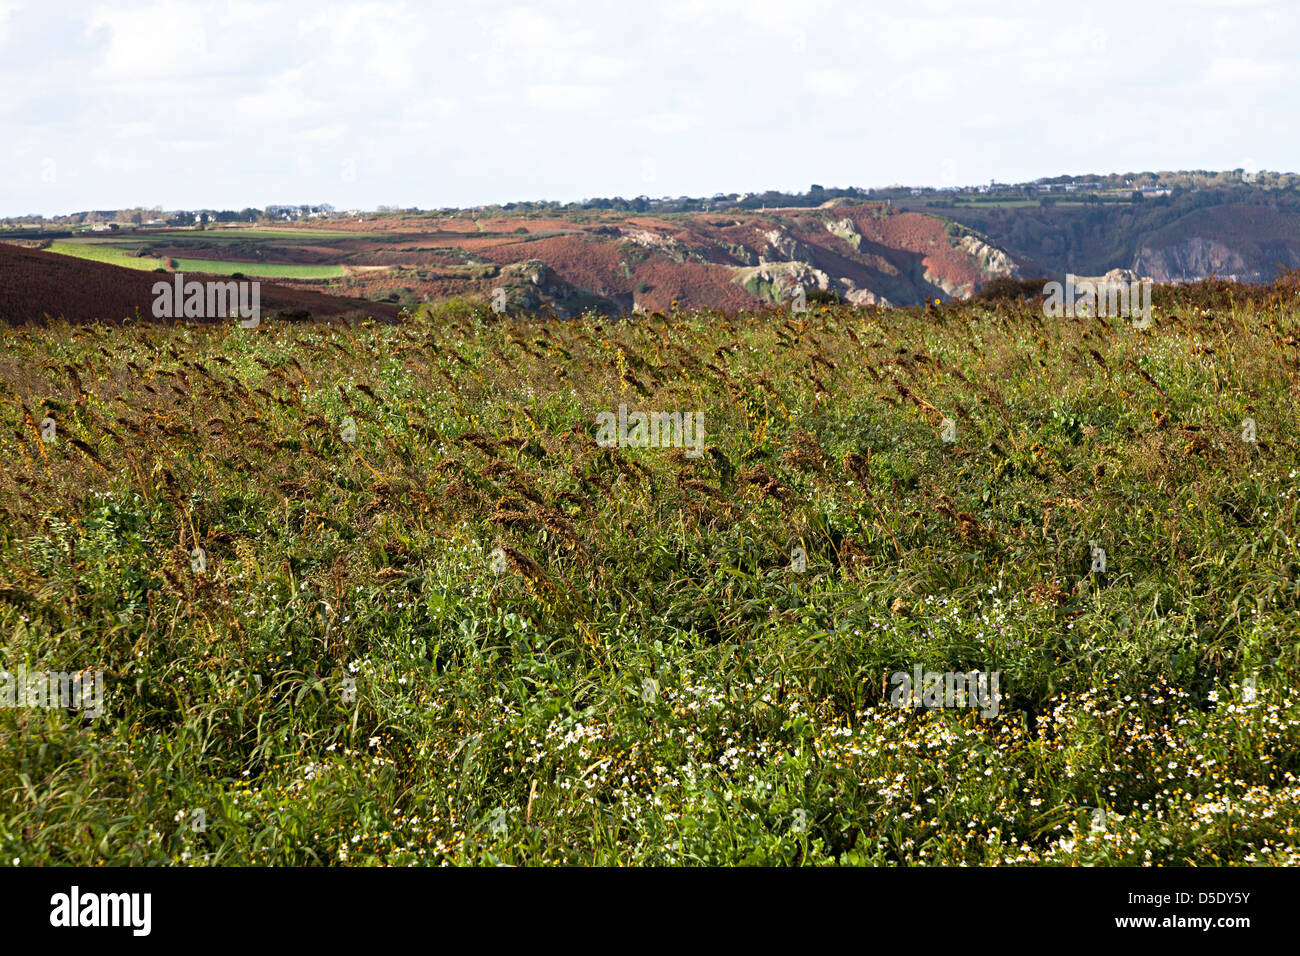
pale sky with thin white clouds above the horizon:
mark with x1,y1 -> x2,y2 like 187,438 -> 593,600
0,0 -> 1300,216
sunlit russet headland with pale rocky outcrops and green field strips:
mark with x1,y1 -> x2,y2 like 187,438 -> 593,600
12,199 -> 1019,316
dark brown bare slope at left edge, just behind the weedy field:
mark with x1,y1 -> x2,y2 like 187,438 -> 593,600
0,242 -> 398,325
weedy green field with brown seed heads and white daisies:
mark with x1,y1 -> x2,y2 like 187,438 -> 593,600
0,286 -> 1300,865
